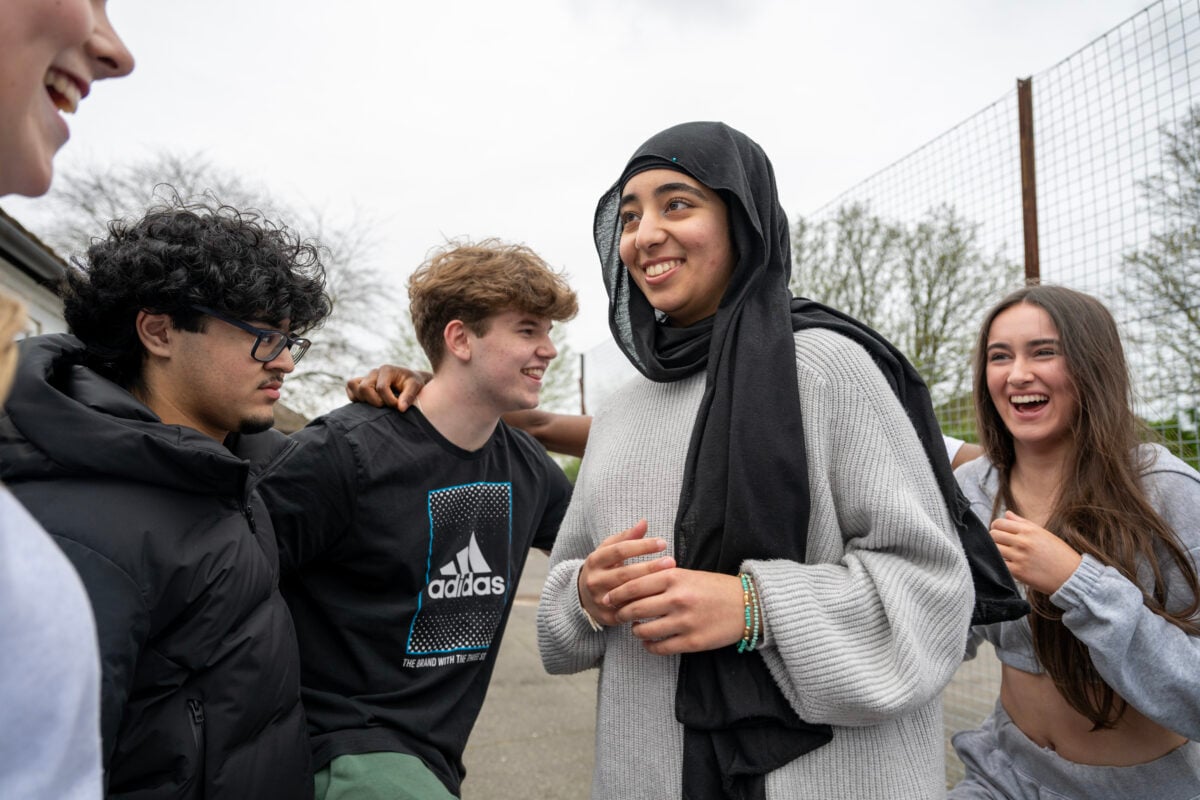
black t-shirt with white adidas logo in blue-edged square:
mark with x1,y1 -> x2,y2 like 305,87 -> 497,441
262,404 -> 571,794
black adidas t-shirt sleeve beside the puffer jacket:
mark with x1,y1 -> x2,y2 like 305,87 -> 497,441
259,417 -> 359,573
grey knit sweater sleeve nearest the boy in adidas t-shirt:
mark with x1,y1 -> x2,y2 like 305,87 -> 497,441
538,456 -> 604,675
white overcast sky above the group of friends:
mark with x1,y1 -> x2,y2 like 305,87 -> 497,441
5,0 -> 1146,350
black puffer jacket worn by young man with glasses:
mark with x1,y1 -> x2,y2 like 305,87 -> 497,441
0,335 -> 312,800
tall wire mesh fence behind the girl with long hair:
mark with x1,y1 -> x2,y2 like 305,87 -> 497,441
583,0 -> 1200,783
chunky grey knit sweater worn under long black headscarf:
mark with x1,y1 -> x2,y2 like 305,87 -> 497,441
538,330 -> 973,800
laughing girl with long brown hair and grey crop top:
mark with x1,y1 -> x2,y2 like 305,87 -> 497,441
950,285 -> 1200,800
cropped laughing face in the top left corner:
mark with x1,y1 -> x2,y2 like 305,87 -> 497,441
0,0 -> 133,197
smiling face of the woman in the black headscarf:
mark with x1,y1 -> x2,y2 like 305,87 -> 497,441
619,169 -> 737,326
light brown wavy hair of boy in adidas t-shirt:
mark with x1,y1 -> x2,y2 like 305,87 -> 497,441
408,239 -> 578,369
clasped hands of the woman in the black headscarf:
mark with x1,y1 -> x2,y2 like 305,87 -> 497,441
578,519 -> 745,655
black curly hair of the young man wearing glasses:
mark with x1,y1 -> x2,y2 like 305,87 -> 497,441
61,198 -> 332,387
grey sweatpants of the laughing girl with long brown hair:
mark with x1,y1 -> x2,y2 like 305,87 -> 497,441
948,703 -> 1200,800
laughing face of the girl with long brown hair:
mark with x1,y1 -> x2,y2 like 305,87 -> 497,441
985,303 -> 1079,453
